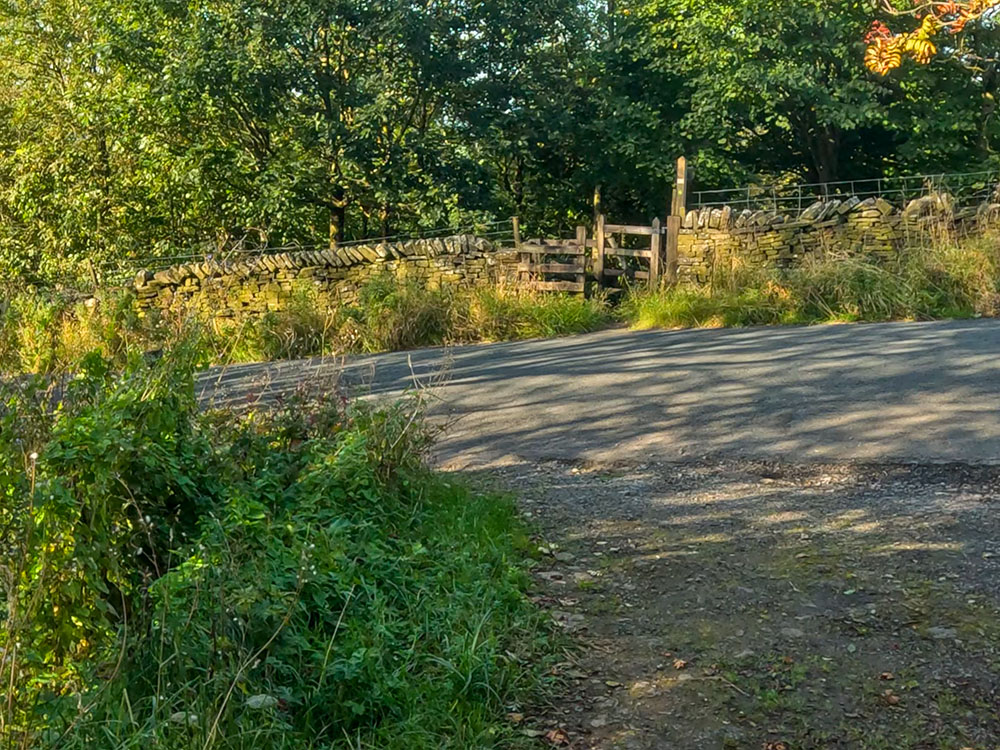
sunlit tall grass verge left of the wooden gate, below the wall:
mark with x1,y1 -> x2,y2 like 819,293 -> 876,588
0,277 -> 611,372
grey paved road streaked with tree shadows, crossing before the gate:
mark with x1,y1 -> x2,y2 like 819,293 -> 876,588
197,320 -> 1000,465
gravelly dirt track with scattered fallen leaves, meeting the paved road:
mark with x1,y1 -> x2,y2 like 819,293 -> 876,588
472,461 -> 1000,750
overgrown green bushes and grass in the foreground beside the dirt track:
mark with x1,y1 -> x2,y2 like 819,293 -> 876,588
0,347 -> 545,750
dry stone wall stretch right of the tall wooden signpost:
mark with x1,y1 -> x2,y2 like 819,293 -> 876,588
677,194 -> 1000,283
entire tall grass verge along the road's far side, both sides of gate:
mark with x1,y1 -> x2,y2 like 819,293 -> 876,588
7,229 -> 1000,372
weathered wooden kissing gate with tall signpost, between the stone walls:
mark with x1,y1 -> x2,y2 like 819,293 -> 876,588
514,157 -> 691,294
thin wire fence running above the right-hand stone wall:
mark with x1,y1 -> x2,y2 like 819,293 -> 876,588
689,169 -> 1000,213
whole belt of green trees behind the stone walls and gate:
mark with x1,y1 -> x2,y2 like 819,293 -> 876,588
0,0 -> 997,280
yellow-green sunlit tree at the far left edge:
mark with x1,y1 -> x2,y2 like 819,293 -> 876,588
0,0 -> 164,276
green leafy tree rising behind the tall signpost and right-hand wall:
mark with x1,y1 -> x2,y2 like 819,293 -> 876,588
620,0 -> 886,186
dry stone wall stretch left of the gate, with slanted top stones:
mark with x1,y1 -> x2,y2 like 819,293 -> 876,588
134,235 -> 517,317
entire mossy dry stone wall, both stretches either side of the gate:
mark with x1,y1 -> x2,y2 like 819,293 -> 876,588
134,194 -> 1000,317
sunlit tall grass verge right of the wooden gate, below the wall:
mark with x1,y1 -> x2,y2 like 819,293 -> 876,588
619,236 -> 1000,328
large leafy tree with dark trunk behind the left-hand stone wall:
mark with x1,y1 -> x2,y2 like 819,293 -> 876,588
115,0 -> 584,241
